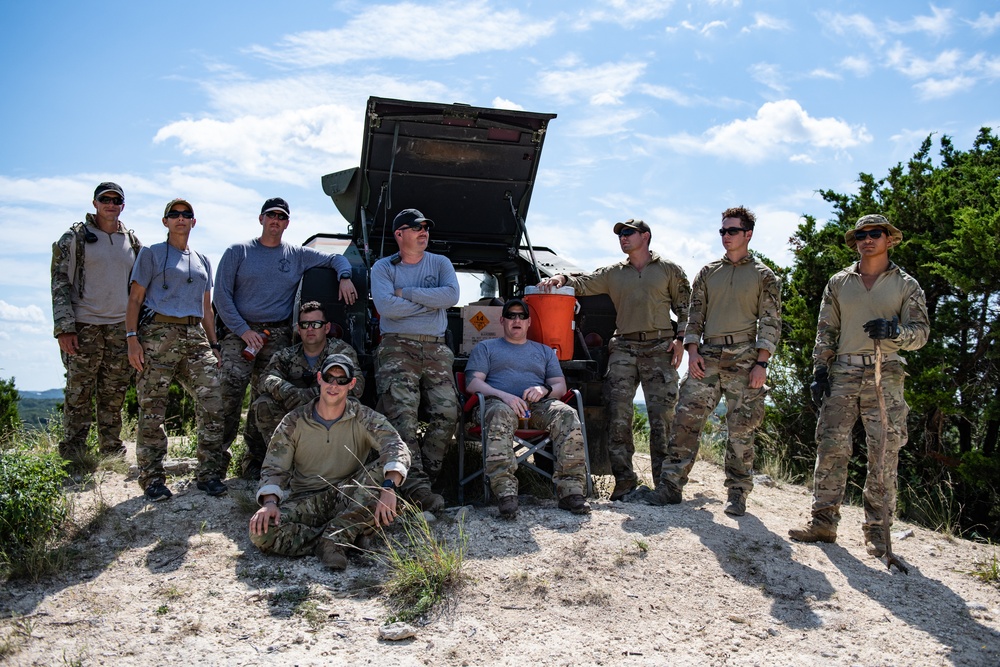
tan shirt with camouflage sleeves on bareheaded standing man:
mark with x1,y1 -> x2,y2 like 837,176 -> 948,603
684,255 -> 781,354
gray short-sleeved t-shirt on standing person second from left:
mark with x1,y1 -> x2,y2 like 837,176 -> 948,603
130,242 -> 212,317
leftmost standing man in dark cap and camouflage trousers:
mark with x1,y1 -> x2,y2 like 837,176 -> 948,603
52,181 -> 142,472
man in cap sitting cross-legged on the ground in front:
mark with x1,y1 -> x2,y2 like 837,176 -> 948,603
250,354 -> 410,570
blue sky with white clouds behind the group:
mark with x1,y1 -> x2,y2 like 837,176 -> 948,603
0,0 -> 1000,390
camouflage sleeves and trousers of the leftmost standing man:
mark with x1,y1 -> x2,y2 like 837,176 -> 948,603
51,213 -> 142,461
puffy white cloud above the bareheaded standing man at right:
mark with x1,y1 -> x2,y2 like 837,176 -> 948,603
664,100 -> 872,163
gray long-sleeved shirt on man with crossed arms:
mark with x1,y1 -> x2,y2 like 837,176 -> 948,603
372,252 -> 458,336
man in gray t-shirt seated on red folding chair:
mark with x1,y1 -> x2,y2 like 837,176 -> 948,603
465,299 -> 590,519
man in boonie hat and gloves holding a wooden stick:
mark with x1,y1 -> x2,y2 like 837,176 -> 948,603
788,214 -> 930,557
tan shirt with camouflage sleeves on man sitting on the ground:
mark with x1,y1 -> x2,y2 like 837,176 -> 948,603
257,398 -> 410,501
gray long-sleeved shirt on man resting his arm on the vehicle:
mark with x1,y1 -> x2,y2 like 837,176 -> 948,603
215,239 -> 351,336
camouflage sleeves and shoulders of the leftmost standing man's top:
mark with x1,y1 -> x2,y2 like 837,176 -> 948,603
51,213 -> 142,336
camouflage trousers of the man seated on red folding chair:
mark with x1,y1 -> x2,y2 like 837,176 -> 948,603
473,396 -> 587,498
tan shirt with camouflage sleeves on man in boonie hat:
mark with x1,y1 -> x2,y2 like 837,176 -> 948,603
813,262 -> 931,369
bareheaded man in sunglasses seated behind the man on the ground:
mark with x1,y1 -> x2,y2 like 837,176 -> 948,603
250,301 -> 365,470
